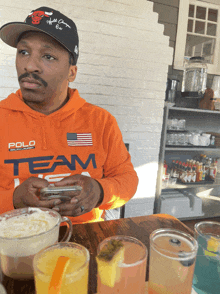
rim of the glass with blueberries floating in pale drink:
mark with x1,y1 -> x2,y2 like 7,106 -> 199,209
150,228 -> 198,261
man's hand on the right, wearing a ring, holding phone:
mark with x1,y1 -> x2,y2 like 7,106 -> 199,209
54,175 -> 103,216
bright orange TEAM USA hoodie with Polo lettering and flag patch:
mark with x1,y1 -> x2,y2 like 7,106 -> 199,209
0,89 -> 138,223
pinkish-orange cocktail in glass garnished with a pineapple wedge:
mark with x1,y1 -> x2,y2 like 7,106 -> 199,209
96,236 -> 148,294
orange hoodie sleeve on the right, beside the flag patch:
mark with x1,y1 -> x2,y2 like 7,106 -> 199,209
96,117 -> 138,210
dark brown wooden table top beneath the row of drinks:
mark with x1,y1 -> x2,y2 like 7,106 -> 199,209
3,214 -> 218,294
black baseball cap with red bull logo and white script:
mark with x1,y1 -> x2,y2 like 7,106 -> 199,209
0,7 -> 79,63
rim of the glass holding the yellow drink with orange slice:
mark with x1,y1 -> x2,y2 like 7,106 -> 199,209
33,242 -> 90,279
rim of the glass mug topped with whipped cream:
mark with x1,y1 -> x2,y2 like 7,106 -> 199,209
0,207 -> 61,241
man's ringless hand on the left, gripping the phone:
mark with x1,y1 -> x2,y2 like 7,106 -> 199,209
13,177 -> 61,208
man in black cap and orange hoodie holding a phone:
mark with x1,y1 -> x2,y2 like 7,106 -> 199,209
0,7 -> 138,223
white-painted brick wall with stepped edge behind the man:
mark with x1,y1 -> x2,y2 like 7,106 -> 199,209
0,0 -> 173,216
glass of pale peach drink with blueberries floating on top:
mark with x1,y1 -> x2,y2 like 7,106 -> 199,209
148,229 -> 198,294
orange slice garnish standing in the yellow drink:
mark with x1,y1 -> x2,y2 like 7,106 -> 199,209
48,256 -> 70,294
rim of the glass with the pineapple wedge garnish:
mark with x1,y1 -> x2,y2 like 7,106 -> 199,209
97,235 -> 148,267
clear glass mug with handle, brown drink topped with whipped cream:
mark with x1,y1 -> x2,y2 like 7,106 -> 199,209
0,207 -> 72,279
